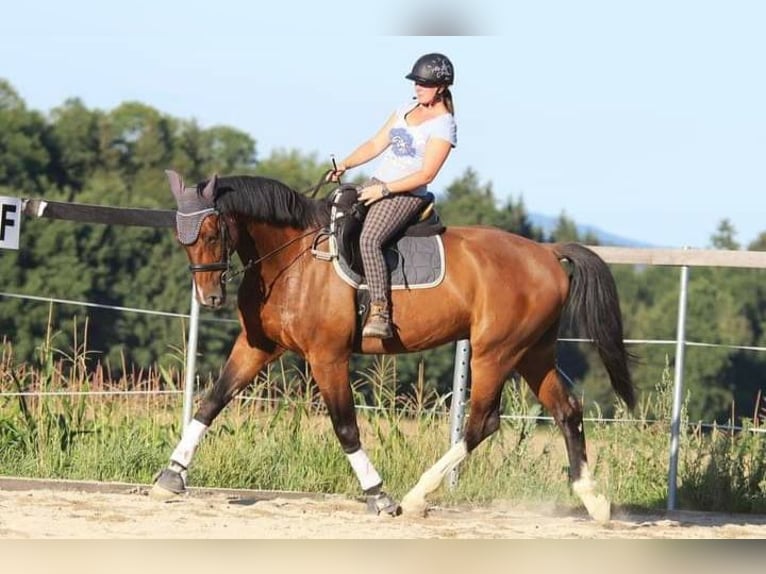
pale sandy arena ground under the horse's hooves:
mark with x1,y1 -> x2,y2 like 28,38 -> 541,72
0,482 -> 766,539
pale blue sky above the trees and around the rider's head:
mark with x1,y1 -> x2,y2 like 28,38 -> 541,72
0,0 -> 766,247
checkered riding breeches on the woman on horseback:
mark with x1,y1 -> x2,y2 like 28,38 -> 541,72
359,194 -> 423,301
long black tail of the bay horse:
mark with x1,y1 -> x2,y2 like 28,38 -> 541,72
553,243 -> 636,409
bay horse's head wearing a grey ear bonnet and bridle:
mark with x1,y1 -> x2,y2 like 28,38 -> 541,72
170,170 -> 232,308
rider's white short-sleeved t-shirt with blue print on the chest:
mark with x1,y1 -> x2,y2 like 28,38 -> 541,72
373,102 -> 457,195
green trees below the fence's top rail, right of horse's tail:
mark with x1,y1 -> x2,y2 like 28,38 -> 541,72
608,266 -> 766,422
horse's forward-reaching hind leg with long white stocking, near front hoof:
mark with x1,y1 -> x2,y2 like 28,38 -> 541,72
402,352 -> 513,514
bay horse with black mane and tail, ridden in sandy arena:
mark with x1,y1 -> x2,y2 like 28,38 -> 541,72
150,170 -> 635,522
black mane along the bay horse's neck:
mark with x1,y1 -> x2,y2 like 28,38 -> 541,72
204,175 -> 330,229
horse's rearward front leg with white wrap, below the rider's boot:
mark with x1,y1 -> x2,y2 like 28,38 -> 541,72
309,359 -> 401,516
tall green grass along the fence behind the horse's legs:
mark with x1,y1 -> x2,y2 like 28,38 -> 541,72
0,326 -> 766,512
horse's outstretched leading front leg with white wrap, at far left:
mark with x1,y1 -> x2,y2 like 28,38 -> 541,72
149,333 -> 283,500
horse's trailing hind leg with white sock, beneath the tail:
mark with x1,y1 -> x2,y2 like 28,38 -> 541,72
518,344 -> 611,522
